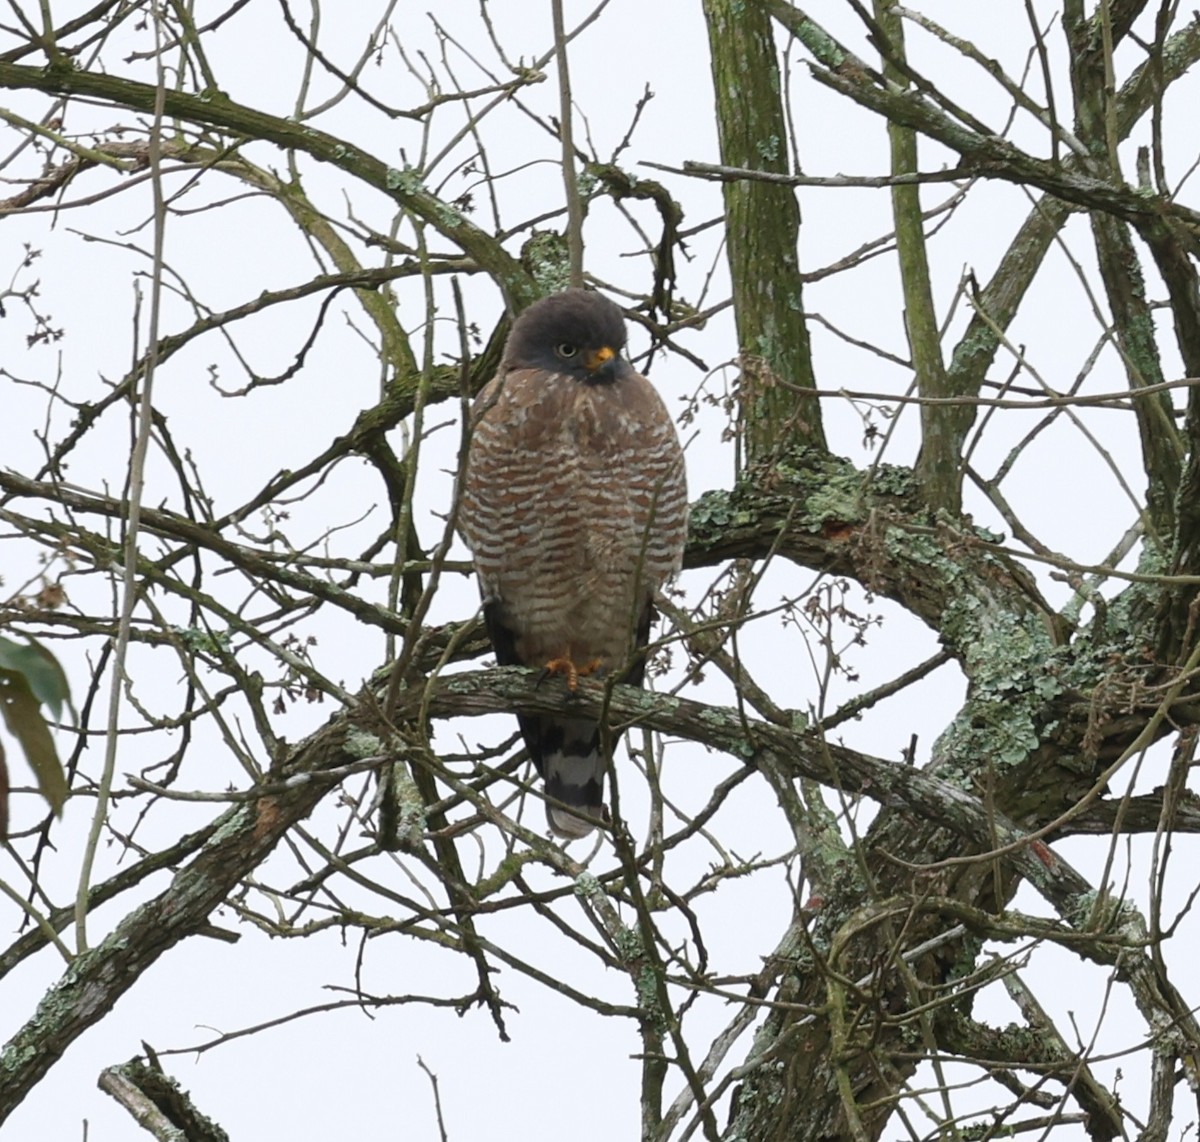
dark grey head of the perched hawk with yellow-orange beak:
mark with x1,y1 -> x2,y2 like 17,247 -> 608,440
504,289 -> 634,384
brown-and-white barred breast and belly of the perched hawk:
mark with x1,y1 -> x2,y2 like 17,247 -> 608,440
460,364 -> 686,665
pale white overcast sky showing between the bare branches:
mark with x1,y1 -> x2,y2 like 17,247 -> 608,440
0,0 -> 1200,1142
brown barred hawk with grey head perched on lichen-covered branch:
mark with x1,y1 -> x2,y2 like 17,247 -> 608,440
458,289 -> 688,839
